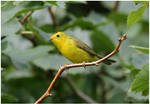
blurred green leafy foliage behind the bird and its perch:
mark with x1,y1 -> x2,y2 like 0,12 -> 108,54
1,1 -> 149,103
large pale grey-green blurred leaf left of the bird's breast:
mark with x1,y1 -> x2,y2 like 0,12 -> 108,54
3,45 -> 53,69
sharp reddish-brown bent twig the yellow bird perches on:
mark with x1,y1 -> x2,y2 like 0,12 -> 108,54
35,34 -> 126,104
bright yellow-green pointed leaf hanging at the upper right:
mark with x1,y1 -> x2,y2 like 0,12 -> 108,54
127,5 -> 146,28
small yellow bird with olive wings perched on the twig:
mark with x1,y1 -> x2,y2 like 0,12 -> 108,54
50,32 -> 115,65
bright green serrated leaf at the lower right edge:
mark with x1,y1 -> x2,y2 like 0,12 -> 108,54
131,64 -> 149,95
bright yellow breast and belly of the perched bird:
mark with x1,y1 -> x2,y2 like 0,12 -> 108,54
59,39 -> 98,63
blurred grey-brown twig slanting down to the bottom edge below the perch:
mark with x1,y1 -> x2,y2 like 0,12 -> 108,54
62,76 -> 96,104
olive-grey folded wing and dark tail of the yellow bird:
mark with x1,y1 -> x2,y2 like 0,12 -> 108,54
70,36 -> 116,64
